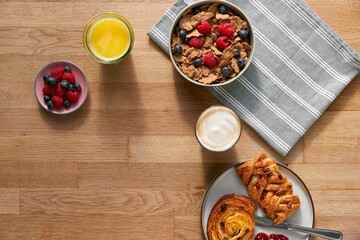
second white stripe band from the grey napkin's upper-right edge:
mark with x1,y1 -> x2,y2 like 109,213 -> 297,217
250,0 -> 351,84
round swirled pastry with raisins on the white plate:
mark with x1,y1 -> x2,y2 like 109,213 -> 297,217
207,194 -> 257,240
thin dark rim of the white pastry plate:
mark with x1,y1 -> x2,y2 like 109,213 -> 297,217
200,159 -> 315,240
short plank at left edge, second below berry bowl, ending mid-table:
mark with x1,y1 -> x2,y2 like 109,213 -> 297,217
0,134 -> 128,163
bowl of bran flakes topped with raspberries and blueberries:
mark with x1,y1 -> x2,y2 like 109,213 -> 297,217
169,1 -> 255,86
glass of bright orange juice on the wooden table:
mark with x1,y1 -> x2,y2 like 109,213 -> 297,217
83,13 -> 134,64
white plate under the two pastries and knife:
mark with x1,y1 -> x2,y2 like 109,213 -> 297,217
201,163 -> 315,240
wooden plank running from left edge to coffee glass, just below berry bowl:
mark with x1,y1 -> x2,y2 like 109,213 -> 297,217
0,109 -> 200,135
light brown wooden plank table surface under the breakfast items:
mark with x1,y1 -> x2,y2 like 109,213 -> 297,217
0,0 -> 360,240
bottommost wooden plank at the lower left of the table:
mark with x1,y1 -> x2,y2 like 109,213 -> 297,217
0,214 -> 175,240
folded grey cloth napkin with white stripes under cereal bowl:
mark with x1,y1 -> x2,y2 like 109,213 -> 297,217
148,0 -> 360,156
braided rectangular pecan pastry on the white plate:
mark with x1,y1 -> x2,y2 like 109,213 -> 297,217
236,153 -> 301,224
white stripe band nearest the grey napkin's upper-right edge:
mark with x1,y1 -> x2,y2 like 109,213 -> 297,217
282,0 -> 360,68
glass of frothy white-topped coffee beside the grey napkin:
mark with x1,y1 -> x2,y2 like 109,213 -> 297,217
195,106 -> 241,152
